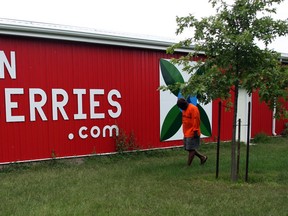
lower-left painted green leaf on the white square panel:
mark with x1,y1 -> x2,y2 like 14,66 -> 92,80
160,105 -> 182,141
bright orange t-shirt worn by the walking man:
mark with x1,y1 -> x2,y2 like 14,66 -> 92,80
182,104 -> 201,137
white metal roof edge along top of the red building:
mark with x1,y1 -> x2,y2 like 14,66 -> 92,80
0,18 -> 192,53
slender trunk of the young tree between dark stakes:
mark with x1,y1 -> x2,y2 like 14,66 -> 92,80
231,82 -> 239,181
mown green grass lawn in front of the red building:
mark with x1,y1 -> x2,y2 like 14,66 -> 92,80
0,137 -> 288,216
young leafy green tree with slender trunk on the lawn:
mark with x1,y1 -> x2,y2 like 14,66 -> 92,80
160,0 -> 288,181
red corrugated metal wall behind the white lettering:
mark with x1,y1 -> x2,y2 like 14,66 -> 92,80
0,36 -> 283,163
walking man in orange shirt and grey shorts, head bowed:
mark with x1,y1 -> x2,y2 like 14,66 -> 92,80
177,98 -> 208,166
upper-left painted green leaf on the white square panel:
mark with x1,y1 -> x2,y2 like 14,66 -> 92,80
160,59 -> 184,97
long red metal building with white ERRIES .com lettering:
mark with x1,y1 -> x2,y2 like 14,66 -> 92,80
0,19 -> 284,164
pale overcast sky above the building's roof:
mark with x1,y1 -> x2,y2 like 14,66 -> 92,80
0,0 -> 288,53
